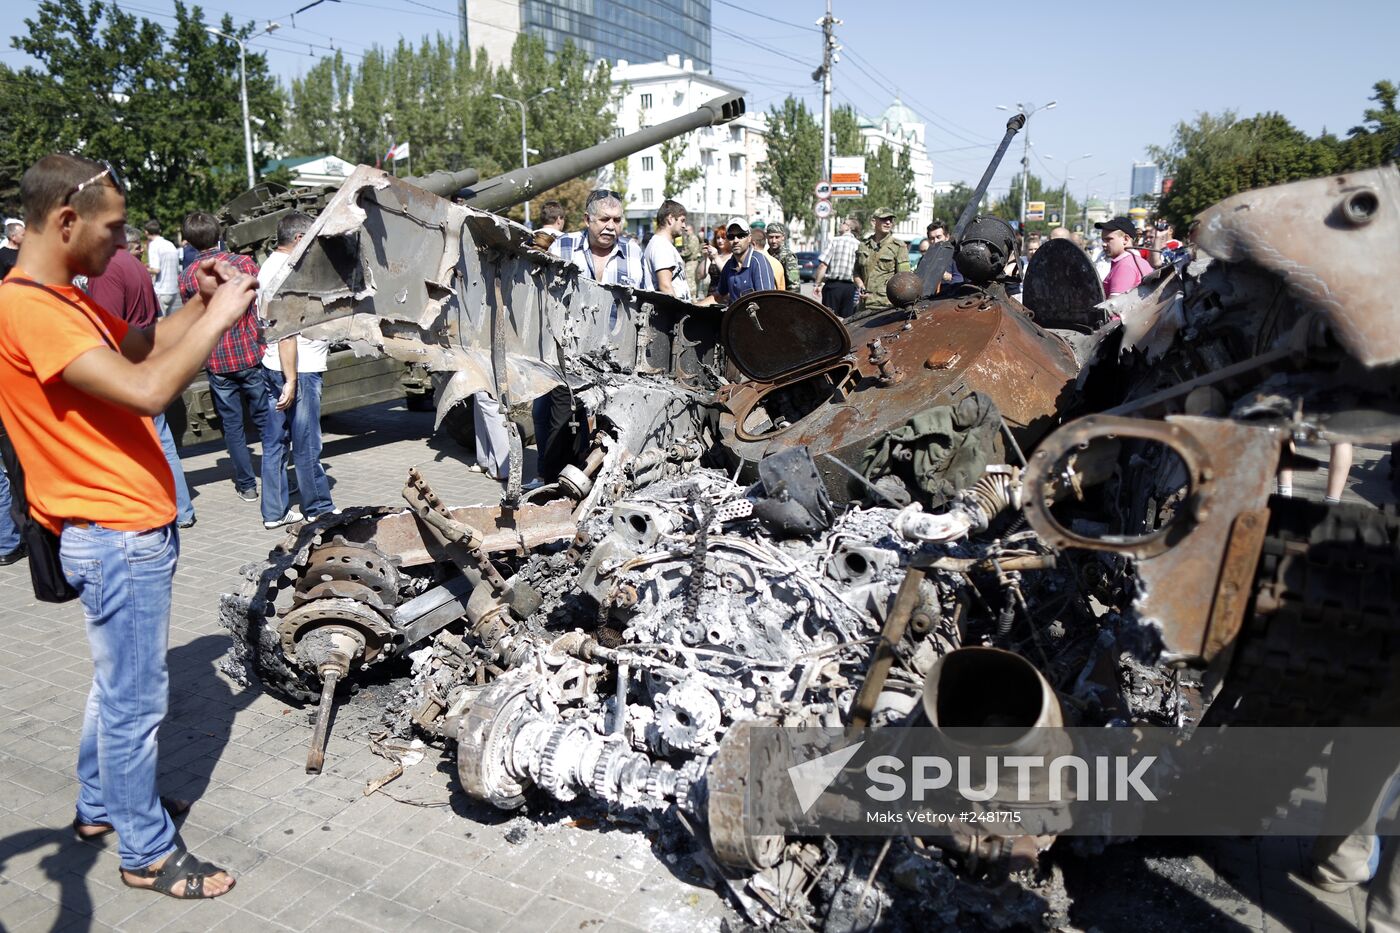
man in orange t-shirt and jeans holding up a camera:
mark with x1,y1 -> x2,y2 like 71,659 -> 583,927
0,156 -> 258,897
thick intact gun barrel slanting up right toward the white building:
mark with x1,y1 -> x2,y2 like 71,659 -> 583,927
459,94 -> 745,210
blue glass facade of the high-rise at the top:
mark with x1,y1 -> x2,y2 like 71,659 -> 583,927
519,0 -> 710,71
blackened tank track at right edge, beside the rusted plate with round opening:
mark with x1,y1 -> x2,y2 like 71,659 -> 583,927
1180,496 -> 1400,835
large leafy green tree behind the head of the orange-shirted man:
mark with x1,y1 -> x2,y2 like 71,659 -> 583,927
0,0 -> 283,228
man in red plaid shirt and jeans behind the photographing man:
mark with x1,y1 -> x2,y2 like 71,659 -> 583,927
179,210 -> 267,502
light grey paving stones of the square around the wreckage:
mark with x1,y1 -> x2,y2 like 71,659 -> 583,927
0,405 -> 1375,933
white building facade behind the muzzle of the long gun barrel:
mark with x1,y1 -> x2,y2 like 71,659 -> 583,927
599,55 -> 781,235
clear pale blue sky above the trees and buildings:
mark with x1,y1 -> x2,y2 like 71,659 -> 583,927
0,0 -> 1400,207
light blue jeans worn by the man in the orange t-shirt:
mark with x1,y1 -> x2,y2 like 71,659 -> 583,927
59,524 -> 179,869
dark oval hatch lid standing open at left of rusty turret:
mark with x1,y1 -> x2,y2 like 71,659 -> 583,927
720,291 -> 851,382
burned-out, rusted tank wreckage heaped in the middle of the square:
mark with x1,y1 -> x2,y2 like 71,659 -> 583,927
221,100 -> 1400,926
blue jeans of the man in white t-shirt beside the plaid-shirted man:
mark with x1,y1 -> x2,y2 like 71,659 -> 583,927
262,367 -> 336,521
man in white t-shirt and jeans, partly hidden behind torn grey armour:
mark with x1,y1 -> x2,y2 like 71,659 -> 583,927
258,210 -> 335,528
